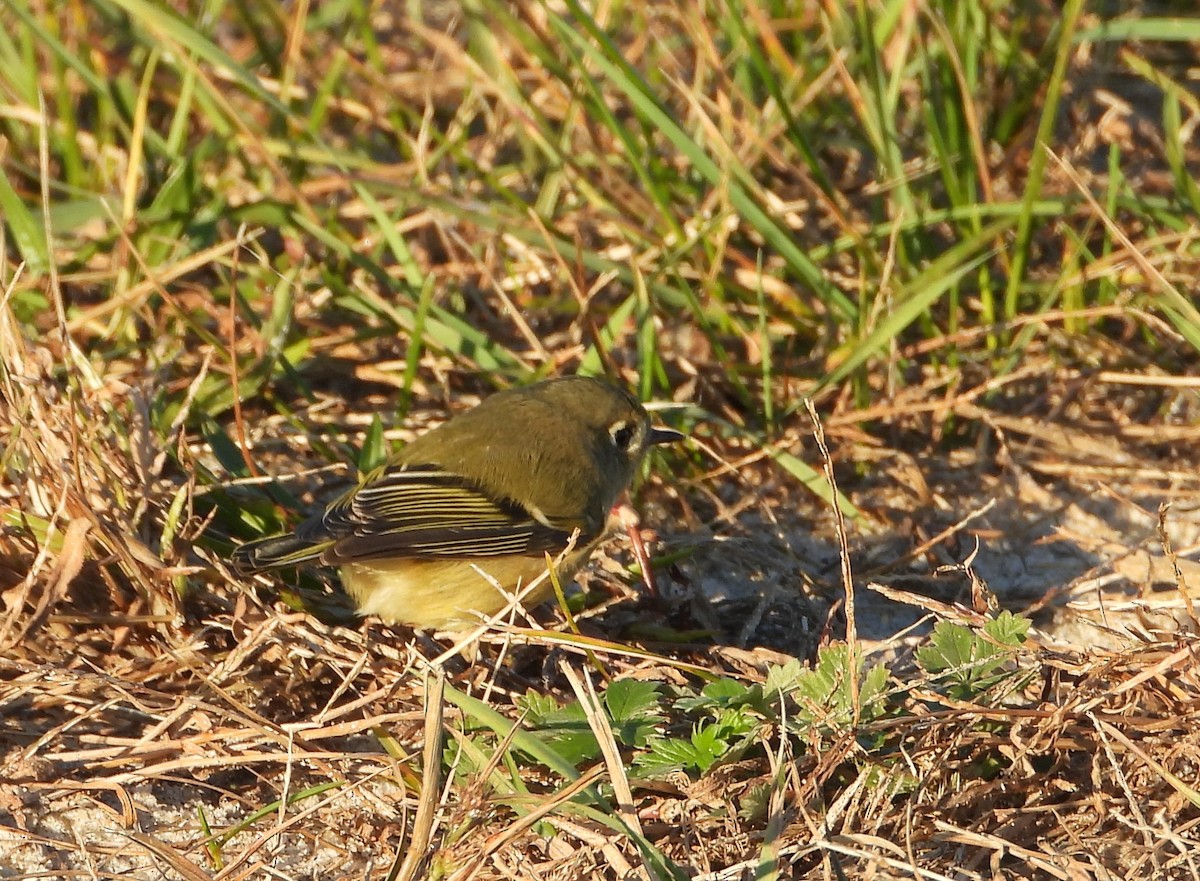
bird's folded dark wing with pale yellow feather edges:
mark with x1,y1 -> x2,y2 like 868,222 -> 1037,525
296,466 -> 580,564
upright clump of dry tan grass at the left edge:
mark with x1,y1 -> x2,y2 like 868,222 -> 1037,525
0,286 -> 179,651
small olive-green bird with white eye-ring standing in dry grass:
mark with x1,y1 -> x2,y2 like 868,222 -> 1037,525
233,376 -> 684,629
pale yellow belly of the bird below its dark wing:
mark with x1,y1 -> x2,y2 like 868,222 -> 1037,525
342,547 -> 592,629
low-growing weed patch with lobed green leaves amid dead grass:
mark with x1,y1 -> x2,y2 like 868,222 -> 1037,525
455,612 -> 1030,781
